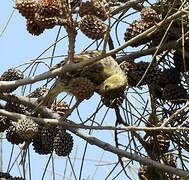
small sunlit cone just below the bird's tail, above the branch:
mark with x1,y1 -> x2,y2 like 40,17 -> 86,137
51,100 -> 69,116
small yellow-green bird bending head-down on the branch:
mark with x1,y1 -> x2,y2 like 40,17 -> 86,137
34,50 -> 127,108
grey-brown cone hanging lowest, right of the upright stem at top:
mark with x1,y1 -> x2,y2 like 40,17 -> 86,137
79,15 -> 107,40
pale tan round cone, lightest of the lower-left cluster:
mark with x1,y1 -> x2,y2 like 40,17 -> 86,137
16,118 -> 39,141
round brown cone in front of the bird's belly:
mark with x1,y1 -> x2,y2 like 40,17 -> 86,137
66,77 -> 96,100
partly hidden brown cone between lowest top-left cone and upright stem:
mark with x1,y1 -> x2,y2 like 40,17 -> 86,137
35,13 -> 56,29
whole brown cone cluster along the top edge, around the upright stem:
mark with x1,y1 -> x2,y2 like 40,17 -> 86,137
15,0 -> 119,40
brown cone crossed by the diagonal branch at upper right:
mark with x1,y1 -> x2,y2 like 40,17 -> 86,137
124,19 -> 154,47
